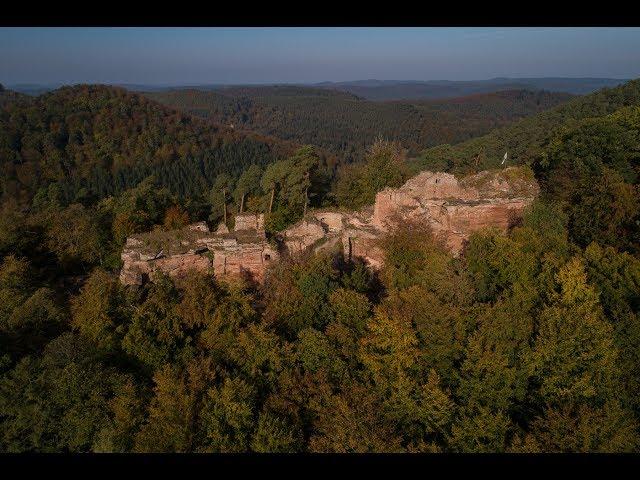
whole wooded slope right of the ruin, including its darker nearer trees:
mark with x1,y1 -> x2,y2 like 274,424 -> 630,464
410,80 -> 640,254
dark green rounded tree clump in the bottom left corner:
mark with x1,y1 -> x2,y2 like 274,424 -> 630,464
0,334 -> 139,452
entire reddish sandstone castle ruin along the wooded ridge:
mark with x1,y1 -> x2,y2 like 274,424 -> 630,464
120,167 -> 539,284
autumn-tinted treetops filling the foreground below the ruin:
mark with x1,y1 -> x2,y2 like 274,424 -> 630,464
0,203 -> 640,452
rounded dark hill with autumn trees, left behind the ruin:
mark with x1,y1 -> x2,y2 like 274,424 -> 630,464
0,85 -> 304,203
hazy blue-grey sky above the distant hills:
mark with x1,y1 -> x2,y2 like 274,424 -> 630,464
0,27 -> 640,85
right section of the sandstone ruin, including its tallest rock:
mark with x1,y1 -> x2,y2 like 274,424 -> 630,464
280,167 -> 539,268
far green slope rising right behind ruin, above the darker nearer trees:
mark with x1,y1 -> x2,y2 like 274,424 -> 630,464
416,80 -> 640,175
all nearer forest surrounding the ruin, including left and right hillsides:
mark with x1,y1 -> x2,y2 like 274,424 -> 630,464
0,81 -> 640,452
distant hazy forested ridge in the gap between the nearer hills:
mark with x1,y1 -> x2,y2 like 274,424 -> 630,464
146,86 -> 571,160
